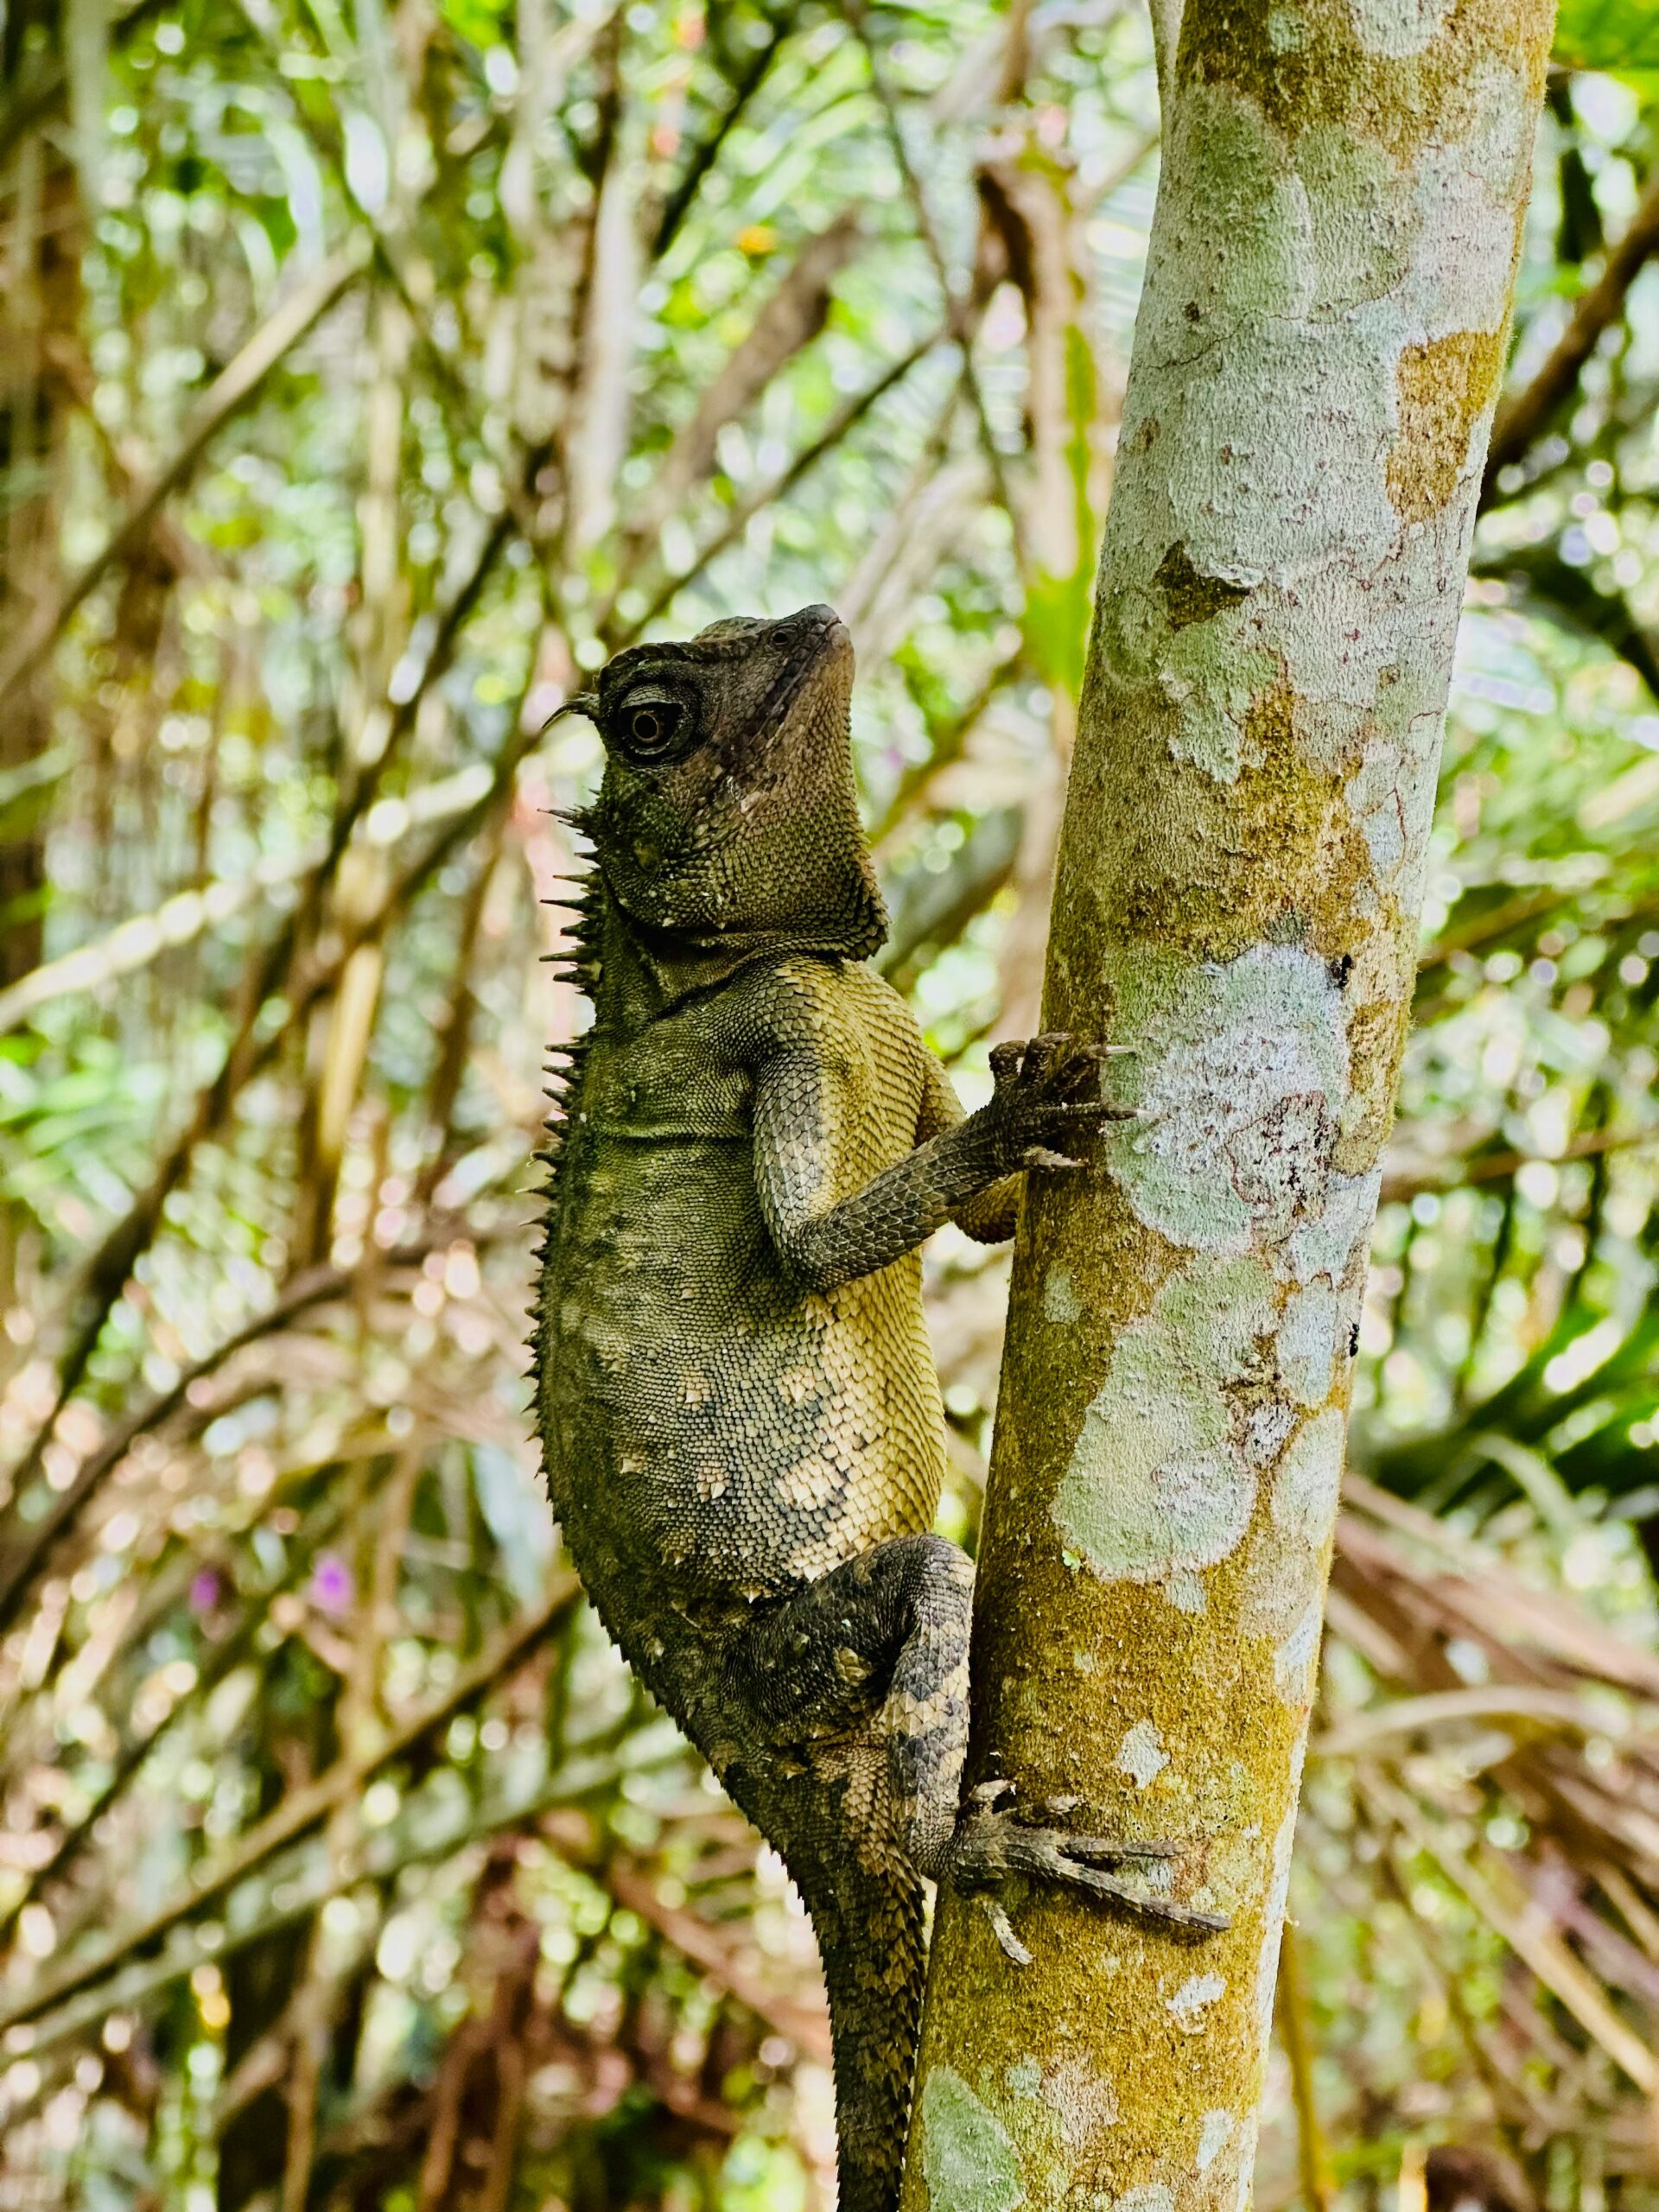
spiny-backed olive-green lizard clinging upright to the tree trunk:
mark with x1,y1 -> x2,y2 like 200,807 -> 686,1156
531,606 -> 1225,2212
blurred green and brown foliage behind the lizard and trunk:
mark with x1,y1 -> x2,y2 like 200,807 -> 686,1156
0,0 -> 1659,2212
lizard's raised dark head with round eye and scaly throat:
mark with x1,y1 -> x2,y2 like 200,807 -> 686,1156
573,606 -> 887,960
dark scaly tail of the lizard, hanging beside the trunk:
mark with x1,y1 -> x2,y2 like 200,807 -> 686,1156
807,1853 -> 927,2212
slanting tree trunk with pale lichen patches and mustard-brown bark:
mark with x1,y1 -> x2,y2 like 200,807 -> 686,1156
905,0 -> 1553,2212
